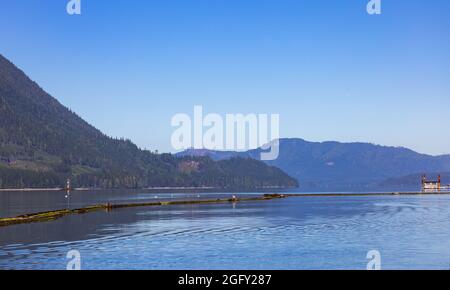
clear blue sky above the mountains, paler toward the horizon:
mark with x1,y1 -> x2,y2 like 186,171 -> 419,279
0,0 -> 450,154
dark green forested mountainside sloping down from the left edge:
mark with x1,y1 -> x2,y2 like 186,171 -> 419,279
0,55 -> 297,189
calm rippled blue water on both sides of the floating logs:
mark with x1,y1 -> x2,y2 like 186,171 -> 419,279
0,192 -> 450,269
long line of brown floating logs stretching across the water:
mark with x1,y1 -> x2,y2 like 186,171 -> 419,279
0,192 -> 450,227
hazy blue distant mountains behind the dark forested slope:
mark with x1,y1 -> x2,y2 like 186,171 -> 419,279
178,139 -> 450,190
